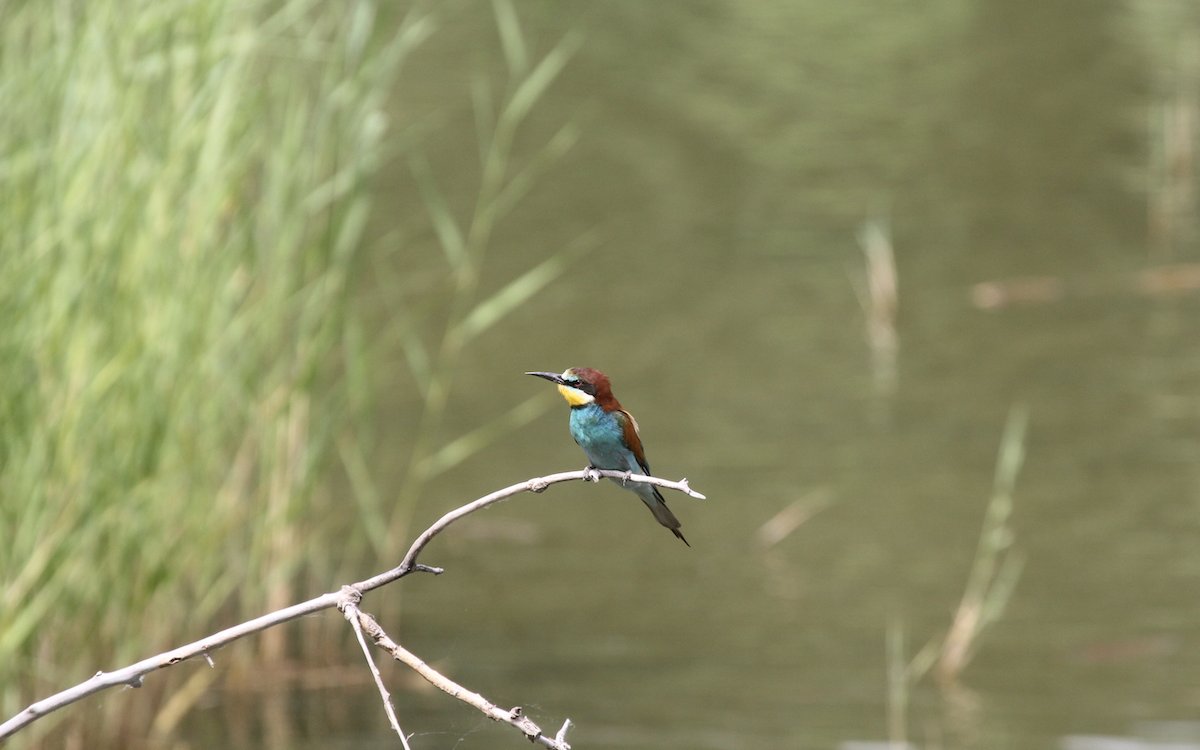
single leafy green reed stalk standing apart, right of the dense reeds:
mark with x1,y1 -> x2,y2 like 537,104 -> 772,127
374,0 -> 583,553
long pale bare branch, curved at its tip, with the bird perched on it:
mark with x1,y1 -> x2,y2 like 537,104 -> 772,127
0,469 -> 704,749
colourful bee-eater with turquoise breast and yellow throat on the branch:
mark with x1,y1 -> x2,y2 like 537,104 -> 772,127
526,367 -> 691,547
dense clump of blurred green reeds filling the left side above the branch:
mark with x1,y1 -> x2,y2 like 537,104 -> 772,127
0,0 -> 429,731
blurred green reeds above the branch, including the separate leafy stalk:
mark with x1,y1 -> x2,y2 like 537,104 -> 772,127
0,0 -> 593,734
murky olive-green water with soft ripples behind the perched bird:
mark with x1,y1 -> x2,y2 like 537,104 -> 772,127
188,0 -> 1200,750
